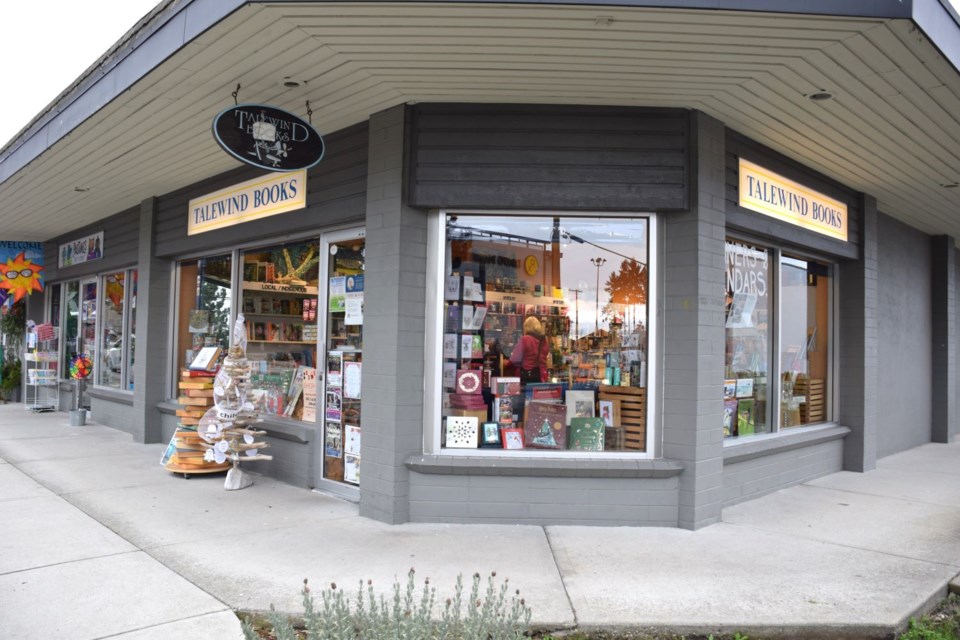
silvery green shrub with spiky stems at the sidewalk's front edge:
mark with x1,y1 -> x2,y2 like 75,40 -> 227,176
243,569 -> 530,640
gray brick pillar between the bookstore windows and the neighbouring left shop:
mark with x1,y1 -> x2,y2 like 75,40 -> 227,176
130,198 -> 173,443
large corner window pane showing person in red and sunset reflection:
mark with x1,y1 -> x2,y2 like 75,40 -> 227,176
440,215 -> 650,452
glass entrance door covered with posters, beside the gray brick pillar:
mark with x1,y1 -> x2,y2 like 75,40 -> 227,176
314,229 -> 366,499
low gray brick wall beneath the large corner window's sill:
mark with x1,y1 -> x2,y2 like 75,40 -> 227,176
410,473 -> 678,527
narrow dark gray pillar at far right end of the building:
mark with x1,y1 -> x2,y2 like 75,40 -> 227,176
930,236 -> 957,442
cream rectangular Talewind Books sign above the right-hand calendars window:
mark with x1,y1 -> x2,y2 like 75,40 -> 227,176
739,158 -> 847,242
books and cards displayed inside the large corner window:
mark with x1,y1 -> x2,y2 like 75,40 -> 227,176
441,269 -> 646,451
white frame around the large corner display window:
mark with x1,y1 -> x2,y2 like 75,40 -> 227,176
422,208 -> 663,460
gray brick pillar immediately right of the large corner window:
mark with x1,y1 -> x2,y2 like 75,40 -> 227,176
662,113 -> 726,529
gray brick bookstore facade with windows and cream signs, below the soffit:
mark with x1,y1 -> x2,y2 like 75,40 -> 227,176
7,3 -> 960,528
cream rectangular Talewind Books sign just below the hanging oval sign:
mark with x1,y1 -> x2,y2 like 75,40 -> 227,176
187,169 -> 307,236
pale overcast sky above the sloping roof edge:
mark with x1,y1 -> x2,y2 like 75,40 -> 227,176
0,0 -> 960,147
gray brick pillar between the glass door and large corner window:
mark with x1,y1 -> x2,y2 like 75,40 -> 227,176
360,107 -> 427,524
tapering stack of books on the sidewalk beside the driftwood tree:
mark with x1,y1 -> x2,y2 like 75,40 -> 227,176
160,369 -> 231,473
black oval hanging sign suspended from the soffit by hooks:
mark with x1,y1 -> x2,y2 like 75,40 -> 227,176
213,104 -> 324,171
